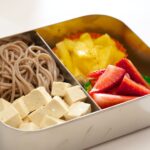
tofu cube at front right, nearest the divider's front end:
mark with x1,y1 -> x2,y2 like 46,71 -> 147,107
65,102 -> 91,120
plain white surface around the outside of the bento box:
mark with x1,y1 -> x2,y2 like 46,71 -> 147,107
0,0 -> 150,150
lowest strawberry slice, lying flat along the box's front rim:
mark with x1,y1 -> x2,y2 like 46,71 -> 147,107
92,93 -> 137,108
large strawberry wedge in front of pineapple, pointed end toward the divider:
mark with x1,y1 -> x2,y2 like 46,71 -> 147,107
90,65 -> 125,94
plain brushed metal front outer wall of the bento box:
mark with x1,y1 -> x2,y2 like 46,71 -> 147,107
0,95 -> 150,150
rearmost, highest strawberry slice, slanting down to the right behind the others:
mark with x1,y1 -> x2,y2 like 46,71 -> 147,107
116,58 -> 149,88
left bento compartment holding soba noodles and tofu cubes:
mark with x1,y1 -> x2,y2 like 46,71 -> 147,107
0,32 -> 98,131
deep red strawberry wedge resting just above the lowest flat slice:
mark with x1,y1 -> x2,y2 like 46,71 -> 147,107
117,75 -> 150,96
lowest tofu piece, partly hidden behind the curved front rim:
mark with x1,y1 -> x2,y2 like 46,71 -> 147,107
19,122 -> 40,131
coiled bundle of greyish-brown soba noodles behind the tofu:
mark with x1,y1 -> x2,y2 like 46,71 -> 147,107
0,41 -> 63,102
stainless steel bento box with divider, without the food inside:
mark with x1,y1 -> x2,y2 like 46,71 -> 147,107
0,15 -> 150,150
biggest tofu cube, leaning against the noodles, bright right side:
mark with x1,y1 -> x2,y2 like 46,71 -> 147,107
23,87 -> 52,112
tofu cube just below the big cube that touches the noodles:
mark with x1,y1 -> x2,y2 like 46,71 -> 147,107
28,107 -> 46,126
